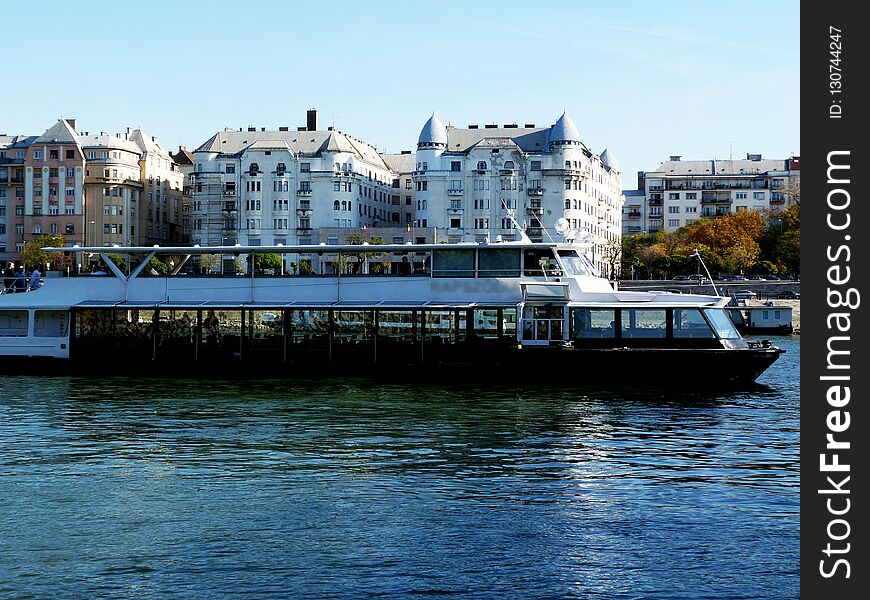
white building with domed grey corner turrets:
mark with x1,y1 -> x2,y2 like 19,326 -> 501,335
413,114 -> 623,268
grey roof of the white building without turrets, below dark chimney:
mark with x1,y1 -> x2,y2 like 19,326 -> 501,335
194,130 -> 386,168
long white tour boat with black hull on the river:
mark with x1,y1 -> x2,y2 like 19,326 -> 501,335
0,236 -> 782,385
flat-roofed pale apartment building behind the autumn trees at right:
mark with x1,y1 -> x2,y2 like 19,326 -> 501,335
623,154 -> 800,234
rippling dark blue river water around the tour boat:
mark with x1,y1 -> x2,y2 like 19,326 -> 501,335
0,337 -> 800,598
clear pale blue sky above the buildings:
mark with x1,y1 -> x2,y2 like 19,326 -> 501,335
0,0 -> 800,188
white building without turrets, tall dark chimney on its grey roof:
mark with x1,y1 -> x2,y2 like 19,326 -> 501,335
192,114 -> 398,251
